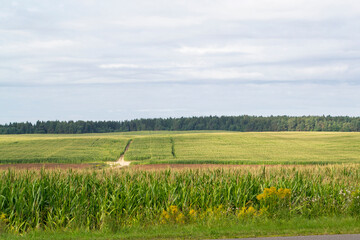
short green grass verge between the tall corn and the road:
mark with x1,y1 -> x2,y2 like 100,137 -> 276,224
0,217 -> 360,240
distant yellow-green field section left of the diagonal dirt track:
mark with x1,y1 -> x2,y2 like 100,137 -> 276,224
0,135 -> 128,163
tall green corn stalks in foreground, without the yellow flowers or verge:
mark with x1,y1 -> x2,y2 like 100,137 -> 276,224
0,165 -> 360,232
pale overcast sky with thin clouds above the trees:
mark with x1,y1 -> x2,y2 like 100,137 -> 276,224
0,0 -> 360,124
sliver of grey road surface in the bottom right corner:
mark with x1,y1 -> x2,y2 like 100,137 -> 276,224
223,234 -> 360,240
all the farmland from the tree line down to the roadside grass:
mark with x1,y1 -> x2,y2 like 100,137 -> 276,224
0,131 -> 360,239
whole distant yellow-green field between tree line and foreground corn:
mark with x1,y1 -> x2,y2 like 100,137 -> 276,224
0,131 -> 360,164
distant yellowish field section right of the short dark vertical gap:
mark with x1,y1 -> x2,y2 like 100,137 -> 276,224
170,132 -> 360,162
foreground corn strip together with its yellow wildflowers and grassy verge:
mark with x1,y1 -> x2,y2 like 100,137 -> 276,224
0,164 -> 360,239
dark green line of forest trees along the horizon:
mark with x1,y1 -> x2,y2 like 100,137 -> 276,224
0,115 -> 360,134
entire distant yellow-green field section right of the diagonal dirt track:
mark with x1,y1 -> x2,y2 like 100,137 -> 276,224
125,132 -> 360,164
